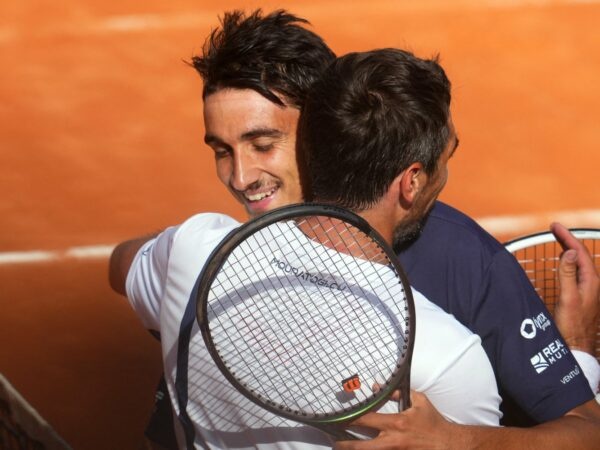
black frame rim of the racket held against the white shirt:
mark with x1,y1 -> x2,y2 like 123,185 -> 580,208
196,202 -> 416,440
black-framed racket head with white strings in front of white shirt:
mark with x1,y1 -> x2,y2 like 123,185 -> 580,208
197,203 -> 415,438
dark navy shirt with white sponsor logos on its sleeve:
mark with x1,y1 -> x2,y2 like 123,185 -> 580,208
399,202 -> 594,424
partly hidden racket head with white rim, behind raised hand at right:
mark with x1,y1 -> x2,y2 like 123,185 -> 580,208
504,228 -> 600,362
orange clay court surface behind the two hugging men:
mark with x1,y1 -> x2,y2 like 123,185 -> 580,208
0,0 -> 600,449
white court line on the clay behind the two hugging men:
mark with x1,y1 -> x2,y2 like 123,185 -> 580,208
0,209 -> 600,266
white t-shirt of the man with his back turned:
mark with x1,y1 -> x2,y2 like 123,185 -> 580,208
127,213 -> 501,449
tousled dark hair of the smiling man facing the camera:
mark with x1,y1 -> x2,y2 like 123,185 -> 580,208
191,9 -> 335,109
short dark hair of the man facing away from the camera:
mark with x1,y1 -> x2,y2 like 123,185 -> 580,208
297,49 -> 450,211
